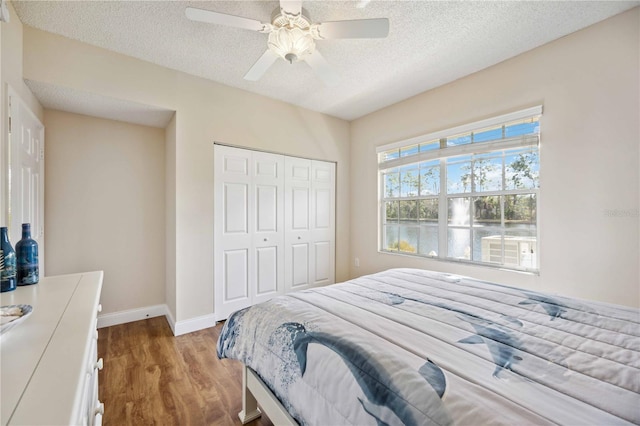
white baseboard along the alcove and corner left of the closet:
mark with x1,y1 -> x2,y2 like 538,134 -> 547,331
98,305 -> 216,336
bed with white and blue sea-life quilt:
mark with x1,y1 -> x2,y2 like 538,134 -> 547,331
217,269 -> 640,426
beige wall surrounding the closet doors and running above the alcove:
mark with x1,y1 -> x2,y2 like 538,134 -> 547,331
24,27 -> 350,322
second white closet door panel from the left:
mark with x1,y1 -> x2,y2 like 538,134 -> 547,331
250,152 -> 284,304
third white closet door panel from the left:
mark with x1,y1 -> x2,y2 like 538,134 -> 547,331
284,157 -> 314,292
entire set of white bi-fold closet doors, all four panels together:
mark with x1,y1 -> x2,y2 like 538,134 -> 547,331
214,145 -> 335,320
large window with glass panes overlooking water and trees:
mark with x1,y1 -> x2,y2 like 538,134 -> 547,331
378,107 -> 542,272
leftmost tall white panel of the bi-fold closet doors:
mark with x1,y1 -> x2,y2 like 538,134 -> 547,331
214,145 -> 254,320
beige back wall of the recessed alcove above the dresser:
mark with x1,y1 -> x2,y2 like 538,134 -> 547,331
44,110 -> 165,312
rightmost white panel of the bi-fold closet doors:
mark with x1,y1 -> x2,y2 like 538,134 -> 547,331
309,161 -> 335,286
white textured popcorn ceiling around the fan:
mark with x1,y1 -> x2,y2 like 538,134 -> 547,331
13,0 -> 640,125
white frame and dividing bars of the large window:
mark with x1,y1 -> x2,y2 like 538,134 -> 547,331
376,106 -> 542,274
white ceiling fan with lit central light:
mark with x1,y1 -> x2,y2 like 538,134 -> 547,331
185,0 -> 389,86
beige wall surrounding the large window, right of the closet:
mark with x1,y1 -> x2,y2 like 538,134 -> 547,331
351,8 -> 640,306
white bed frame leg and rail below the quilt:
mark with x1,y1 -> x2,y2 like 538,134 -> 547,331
238,364 -> 298,426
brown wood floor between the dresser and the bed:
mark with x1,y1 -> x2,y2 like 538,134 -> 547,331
98,317 -> 272,426
